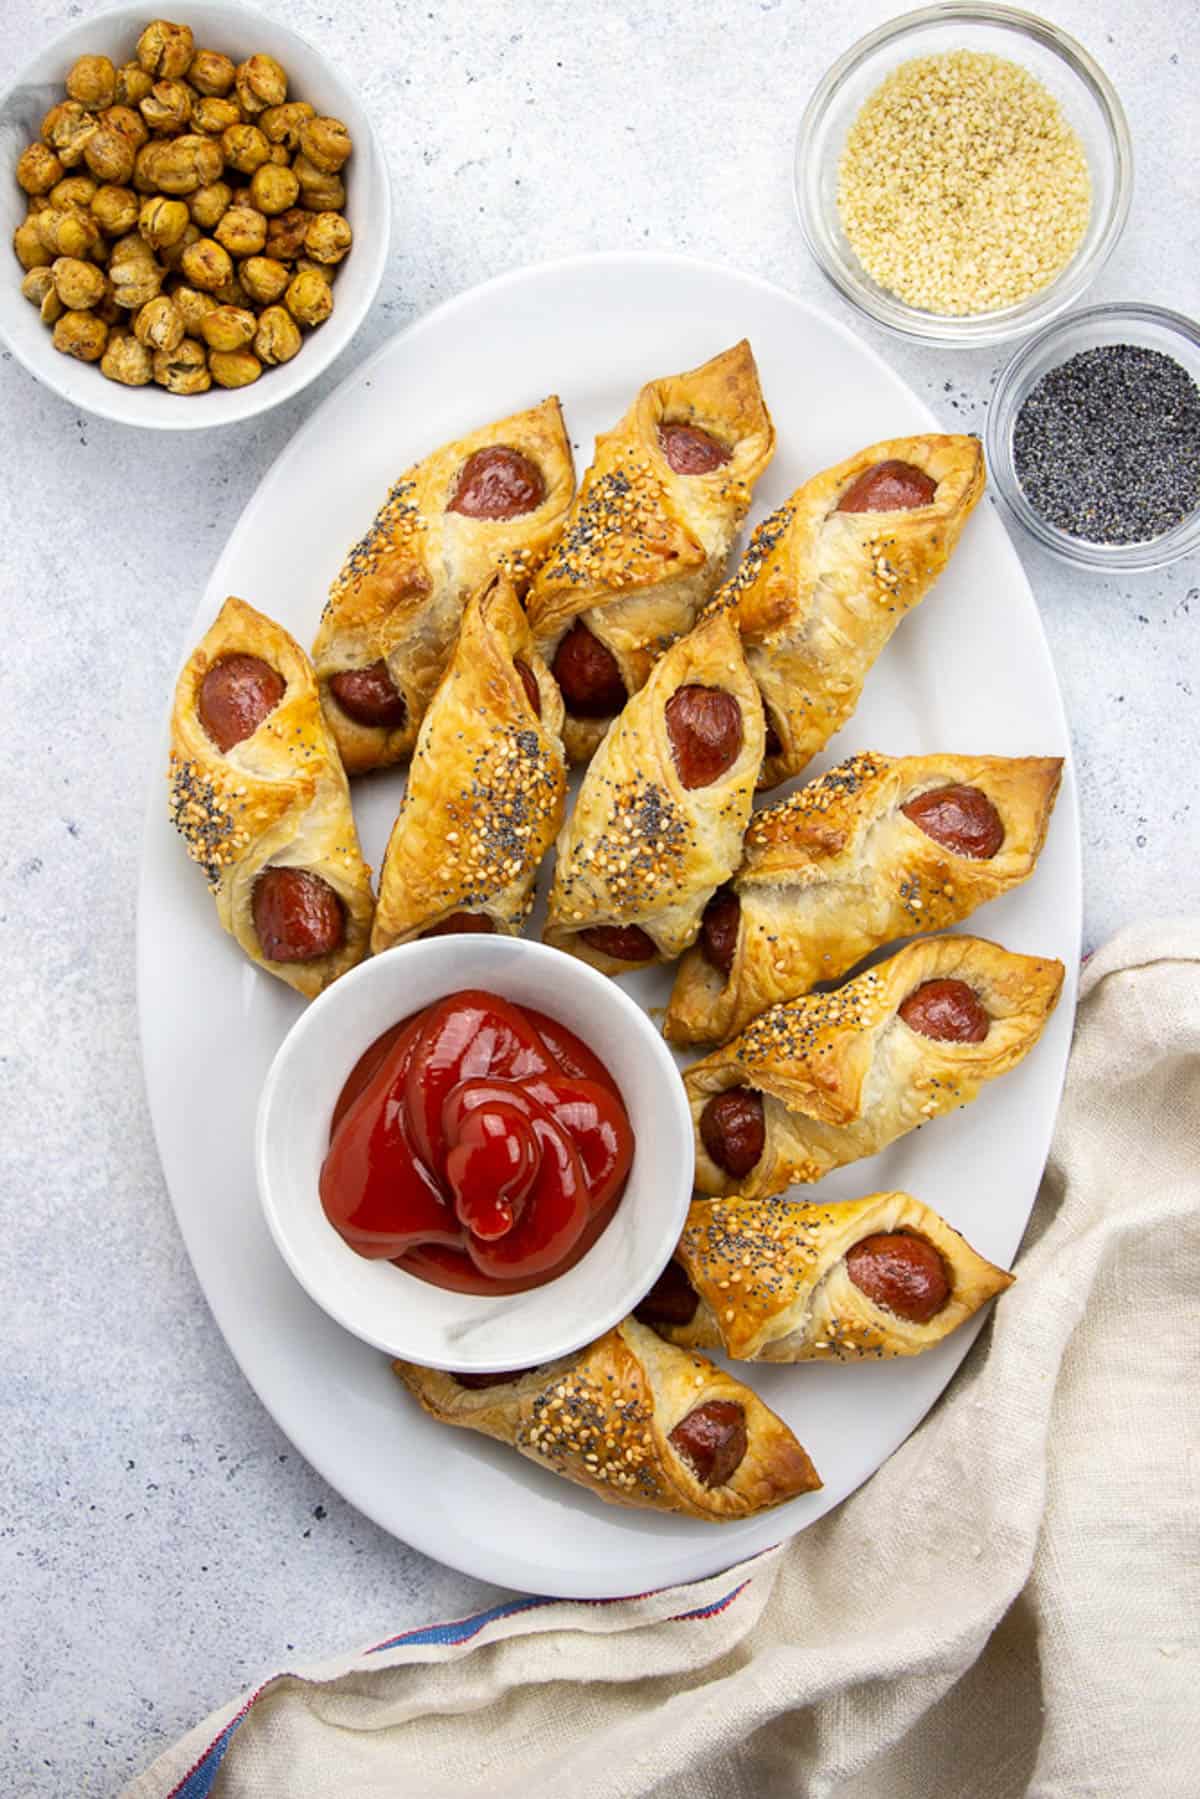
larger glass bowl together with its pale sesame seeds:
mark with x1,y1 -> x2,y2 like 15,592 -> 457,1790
795,4 -> 1133,347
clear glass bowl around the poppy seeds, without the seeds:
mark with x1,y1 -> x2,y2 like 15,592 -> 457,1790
986,304 -> 1200,574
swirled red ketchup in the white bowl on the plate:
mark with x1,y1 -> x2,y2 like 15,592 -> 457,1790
320,989 -> 633,1293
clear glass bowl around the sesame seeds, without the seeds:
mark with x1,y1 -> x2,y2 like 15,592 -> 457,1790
795,4 -> 1133,349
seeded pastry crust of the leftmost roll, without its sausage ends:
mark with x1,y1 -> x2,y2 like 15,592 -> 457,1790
169,597 -> 374,998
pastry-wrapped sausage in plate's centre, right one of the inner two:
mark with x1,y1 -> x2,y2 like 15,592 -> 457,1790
545,615 -> 763,975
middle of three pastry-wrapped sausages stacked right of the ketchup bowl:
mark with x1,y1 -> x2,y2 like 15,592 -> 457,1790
684,937 -> 1063,1198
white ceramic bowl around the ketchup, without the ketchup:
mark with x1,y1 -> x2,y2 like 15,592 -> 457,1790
255,935 -> 694,1374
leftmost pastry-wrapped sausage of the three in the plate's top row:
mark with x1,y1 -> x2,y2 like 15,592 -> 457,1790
313,394 -> 576,774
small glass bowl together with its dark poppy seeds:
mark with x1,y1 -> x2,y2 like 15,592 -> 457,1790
986,304 -> 1200,574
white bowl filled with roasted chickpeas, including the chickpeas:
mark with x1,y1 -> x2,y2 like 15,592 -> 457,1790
0,4 -> 390,430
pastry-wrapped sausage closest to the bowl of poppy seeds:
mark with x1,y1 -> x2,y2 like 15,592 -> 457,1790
712,435 -> 984,788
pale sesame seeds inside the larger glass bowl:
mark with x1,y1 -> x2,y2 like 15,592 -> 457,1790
838,50 -> 1092,315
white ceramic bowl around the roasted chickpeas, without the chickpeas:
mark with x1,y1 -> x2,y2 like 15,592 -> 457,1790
0,0 -> 392,432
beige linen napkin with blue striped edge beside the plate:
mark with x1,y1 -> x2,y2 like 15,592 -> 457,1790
128,921 -> 1200,1799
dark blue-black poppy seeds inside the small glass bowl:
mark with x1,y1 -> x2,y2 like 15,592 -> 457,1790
1013,344 -> 1200,543
